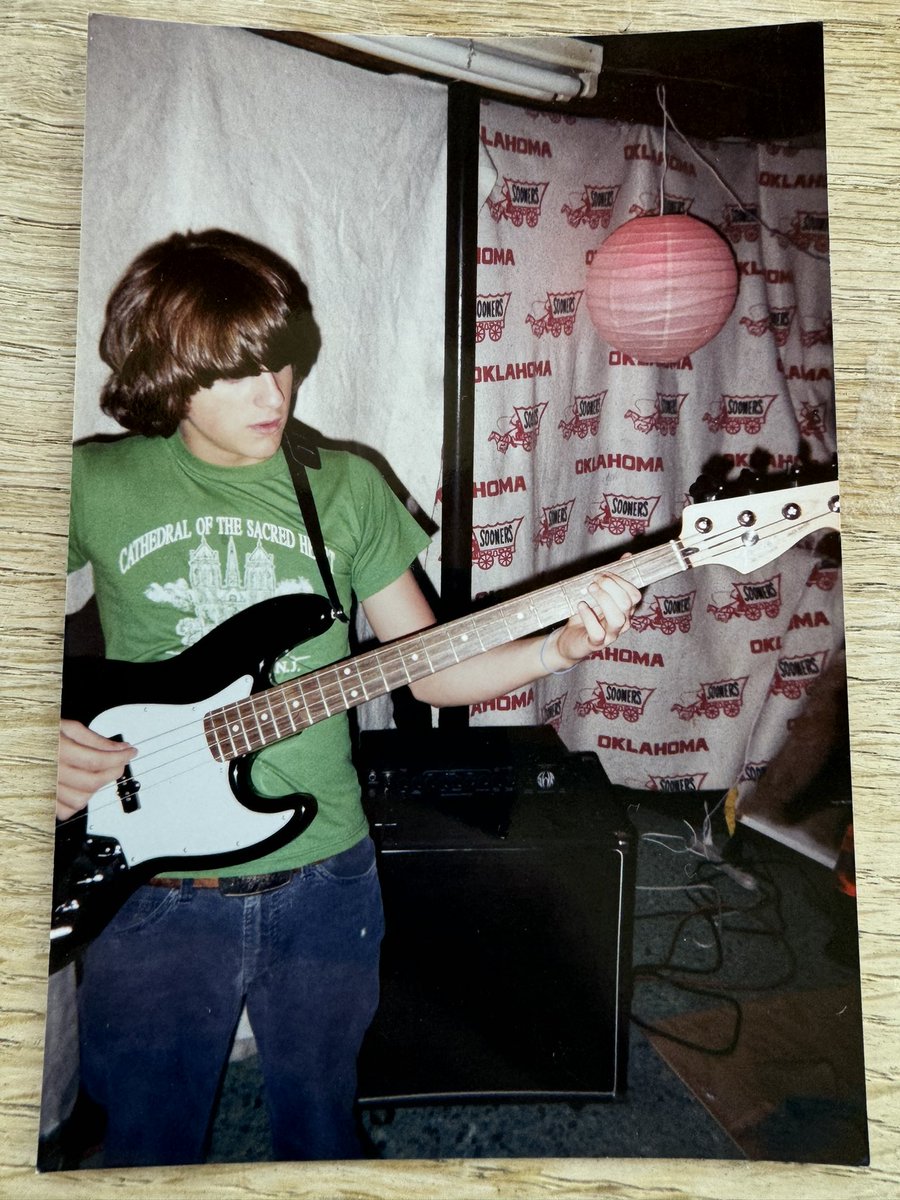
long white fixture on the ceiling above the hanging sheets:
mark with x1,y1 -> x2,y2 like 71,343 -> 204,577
317,34 -> 604,100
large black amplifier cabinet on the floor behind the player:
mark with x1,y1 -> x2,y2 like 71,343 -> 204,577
359,726 -> 636,1106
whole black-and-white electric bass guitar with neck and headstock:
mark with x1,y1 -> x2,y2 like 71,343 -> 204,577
50,472 -> 840,968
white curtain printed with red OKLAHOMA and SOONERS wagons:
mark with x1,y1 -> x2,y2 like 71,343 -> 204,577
427,102 -> 842,806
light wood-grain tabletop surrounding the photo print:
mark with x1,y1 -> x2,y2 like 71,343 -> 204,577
0,0 -> 900,1200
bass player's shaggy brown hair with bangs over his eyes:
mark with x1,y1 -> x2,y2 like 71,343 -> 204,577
100,229 -> 314,437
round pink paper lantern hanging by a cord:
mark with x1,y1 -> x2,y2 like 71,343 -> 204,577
586,214 -> 738,362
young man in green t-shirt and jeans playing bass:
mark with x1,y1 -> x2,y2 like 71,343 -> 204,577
58,229 -> 640,1166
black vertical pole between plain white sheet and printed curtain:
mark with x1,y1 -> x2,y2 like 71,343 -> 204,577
438,83 -> 480,728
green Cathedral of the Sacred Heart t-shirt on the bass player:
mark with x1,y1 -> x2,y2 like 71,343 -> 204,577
68,434 -> 428,875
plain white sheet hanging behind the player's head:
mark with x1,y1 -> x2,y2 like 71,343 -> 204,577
74,17 -> 446,530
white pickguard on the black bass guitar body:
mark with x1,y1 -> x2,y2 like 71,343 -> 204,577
88,676 -> 295,866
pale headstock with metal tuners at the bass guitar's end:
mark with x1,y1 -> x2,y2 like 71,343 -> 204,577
682,480 -> 840,575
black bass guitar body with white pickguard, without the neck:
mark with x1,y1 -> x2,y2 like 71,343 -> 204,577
50,594 -> 332,970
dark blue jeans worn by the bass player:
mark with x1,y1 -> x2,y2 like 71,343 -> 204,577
78,838 -> 384,1166
